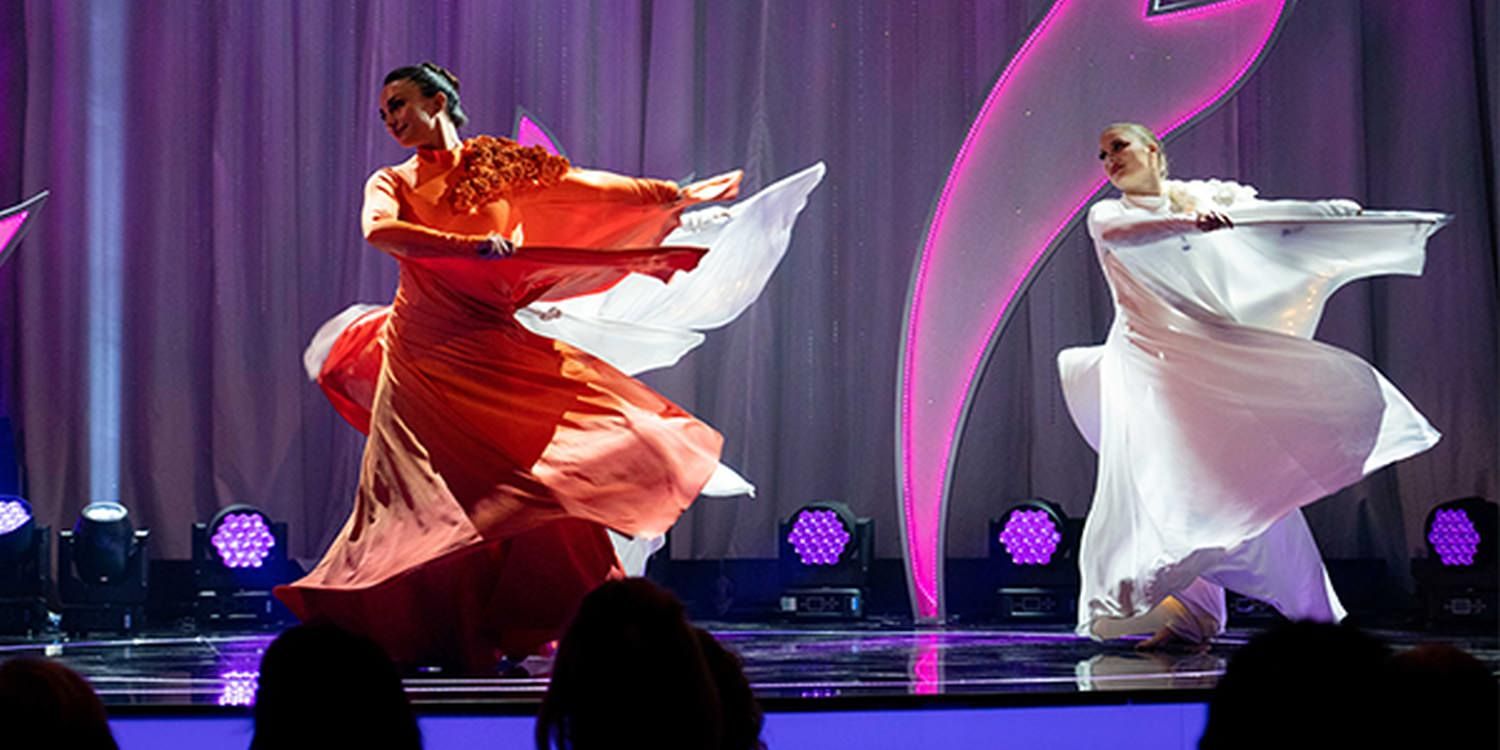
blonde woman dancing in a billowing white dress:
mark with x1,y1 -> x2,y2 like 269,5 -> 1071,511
1058,123 -> 1448,647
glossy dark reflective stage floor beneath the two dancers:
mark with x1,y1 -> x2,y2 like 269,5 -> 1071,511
0,623 -> 1500,716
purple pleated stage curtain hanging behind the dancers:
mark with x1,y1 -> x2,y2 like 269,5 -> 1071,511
0,0 -> 1500,597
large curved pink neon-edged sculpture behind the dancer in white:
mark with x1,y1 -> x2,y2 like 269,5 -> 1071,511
897,0 -> 1287,623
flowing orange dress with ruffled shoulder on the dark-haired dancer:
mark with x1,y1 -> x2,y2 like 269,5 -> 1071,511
276,139 -> 740,671
